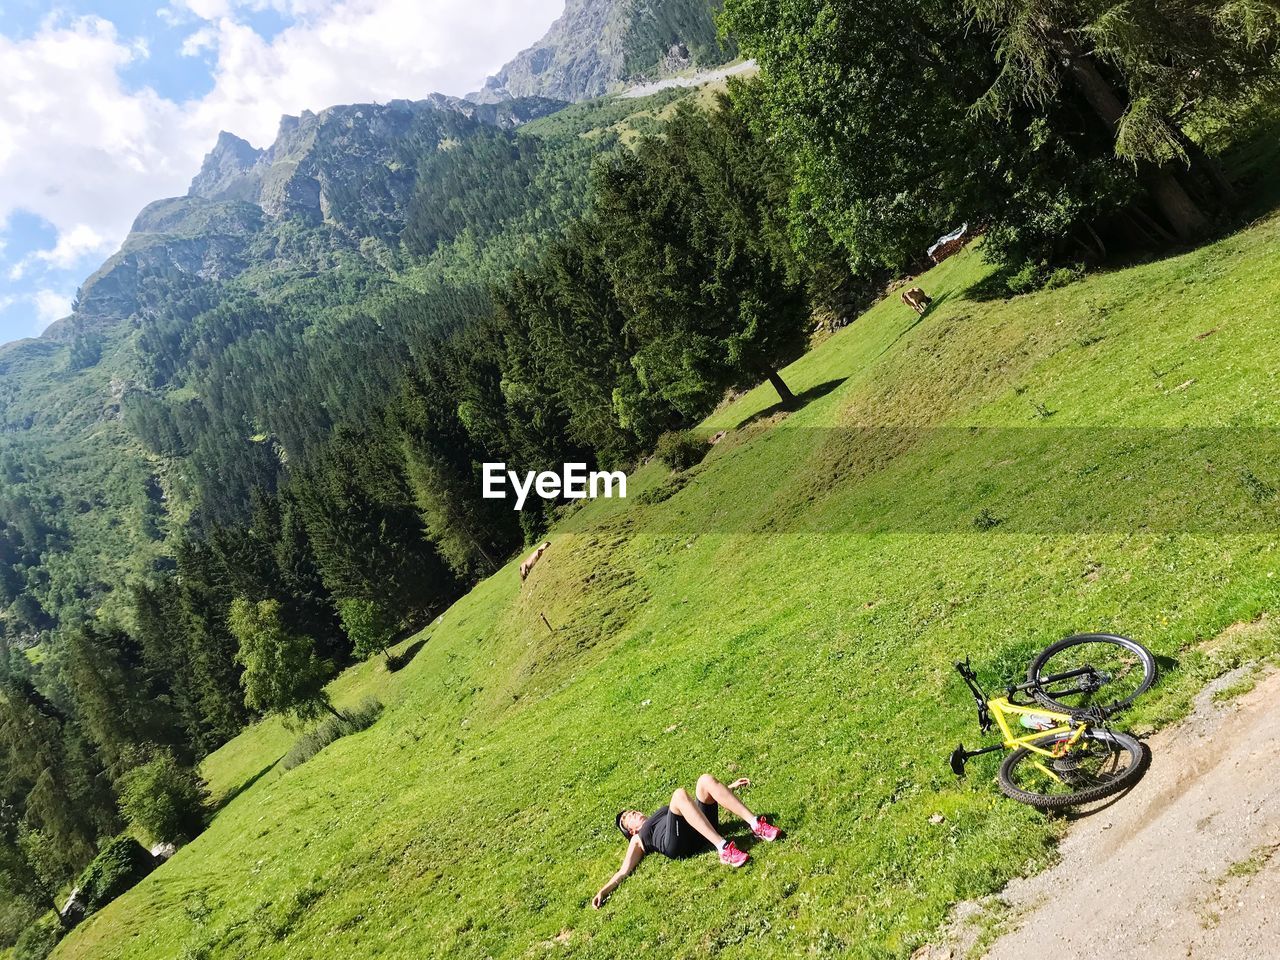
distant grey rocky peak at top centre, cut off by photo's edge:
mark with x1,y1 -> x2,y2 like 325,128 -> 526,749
467,0 -> 733,104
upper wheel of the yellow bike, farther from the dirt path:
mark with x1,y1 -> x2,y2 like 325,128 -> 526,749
1027,634 -> 1156,713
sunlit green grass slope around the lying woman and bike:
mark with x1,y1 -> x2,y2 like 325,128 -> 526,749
55,219 -> 1280,960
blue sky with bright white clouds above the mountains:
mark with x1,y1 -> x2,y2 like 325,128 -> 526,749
0,0 -> 563,342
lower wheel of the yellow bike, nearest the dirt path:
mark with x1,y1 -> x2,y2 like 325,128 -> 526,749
1000,728 -> 1147,810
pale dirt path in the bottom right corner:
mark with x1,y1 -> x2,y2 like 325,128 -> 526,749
918,672 -> 1280,960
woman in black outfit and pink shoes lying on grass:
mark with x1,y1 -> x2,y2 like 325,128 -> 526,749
591,773 -> 778,910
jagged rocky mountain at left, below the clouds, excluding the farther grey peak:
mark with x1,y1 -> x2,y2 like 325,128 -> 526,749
53,93 -> 563,340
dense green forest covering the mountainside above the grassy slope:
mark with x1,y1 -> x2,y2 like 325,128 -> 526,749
0,0 -> 1280,942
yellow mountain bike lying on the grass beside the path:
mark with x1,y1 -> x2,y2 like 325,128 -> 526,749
951,634 -> 1156,810
